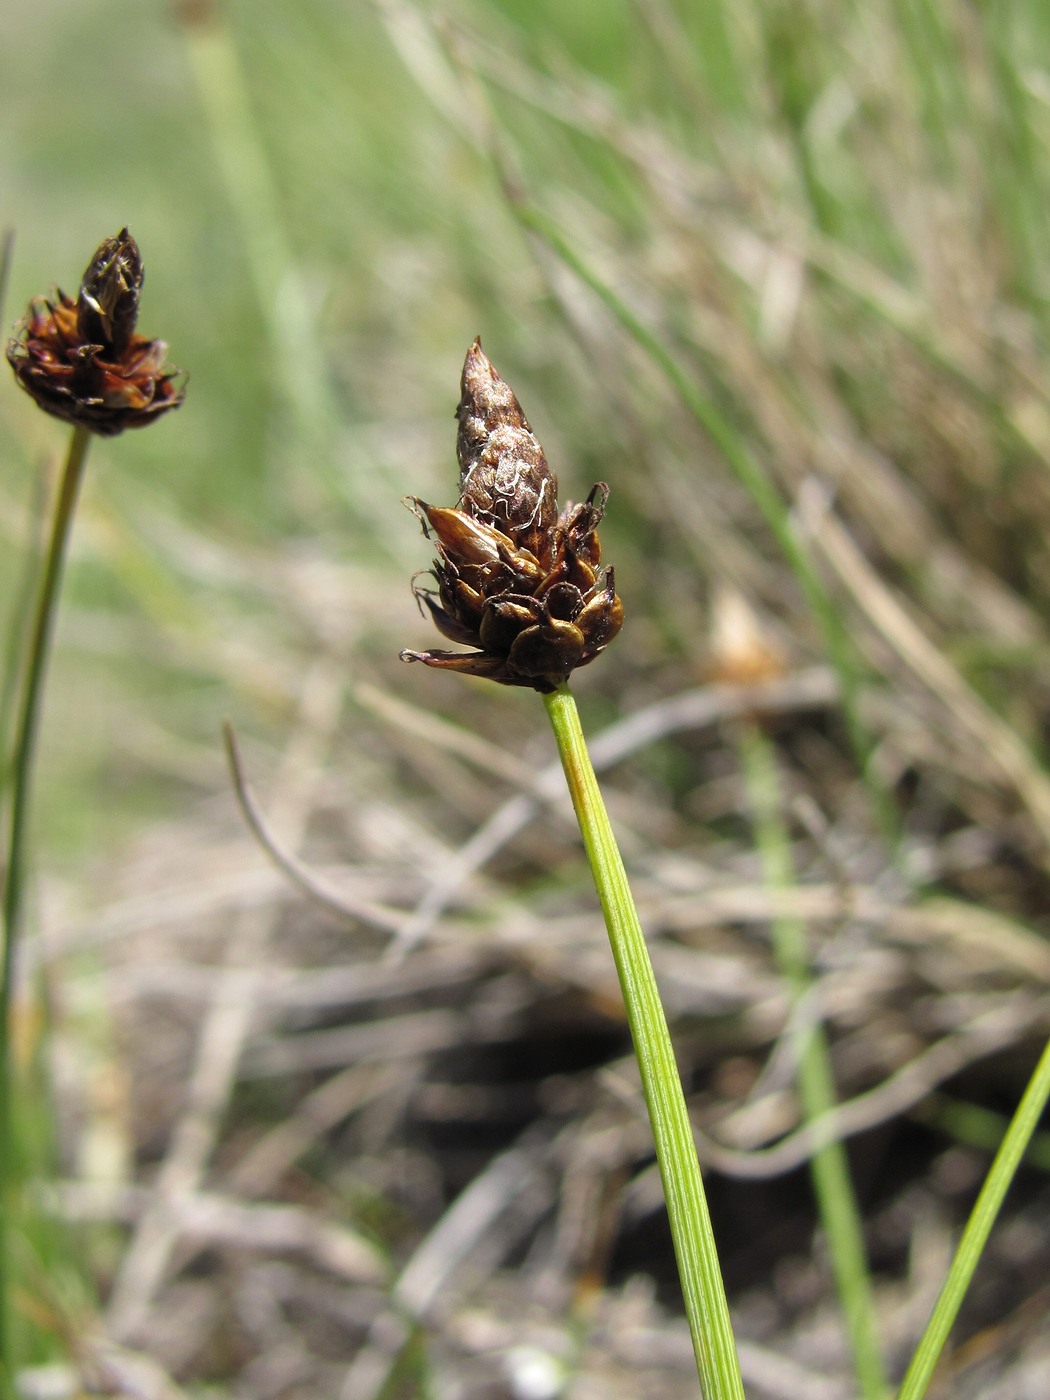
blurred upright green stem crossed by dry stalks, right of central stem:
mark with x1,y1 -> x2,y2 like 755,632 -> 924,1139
739,724 -> 889,1400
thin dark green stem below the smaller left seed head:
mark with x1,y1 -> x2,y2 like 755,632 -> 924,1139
0,427 -> 91,1397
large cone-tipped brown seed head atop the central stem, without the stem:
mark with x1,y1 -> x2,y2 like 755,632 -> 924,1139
402,340 -> 623,693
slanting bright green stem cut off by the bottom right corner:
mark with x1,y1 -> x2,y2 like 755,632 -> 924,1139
897,1042 -> 1050,1400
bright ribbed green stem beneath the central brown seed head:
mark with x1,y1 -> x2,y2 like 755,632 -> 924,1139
543,686 -> 743,1400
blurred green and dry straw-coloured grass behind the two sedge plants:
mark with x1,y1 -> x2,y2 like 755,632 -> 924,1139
0,0 -> 1050,1400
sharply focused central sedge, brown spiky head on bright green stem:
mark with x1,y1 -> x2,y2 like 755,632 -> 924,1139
402,340 -> 743,1400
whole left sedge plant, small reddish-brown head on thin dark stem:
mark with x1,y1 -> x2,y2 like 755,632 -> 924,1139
0,228 -> 185,1400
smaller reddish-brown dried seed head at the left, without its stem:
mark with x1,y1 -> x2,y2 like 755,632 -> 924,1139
7,228 -> 185,437
